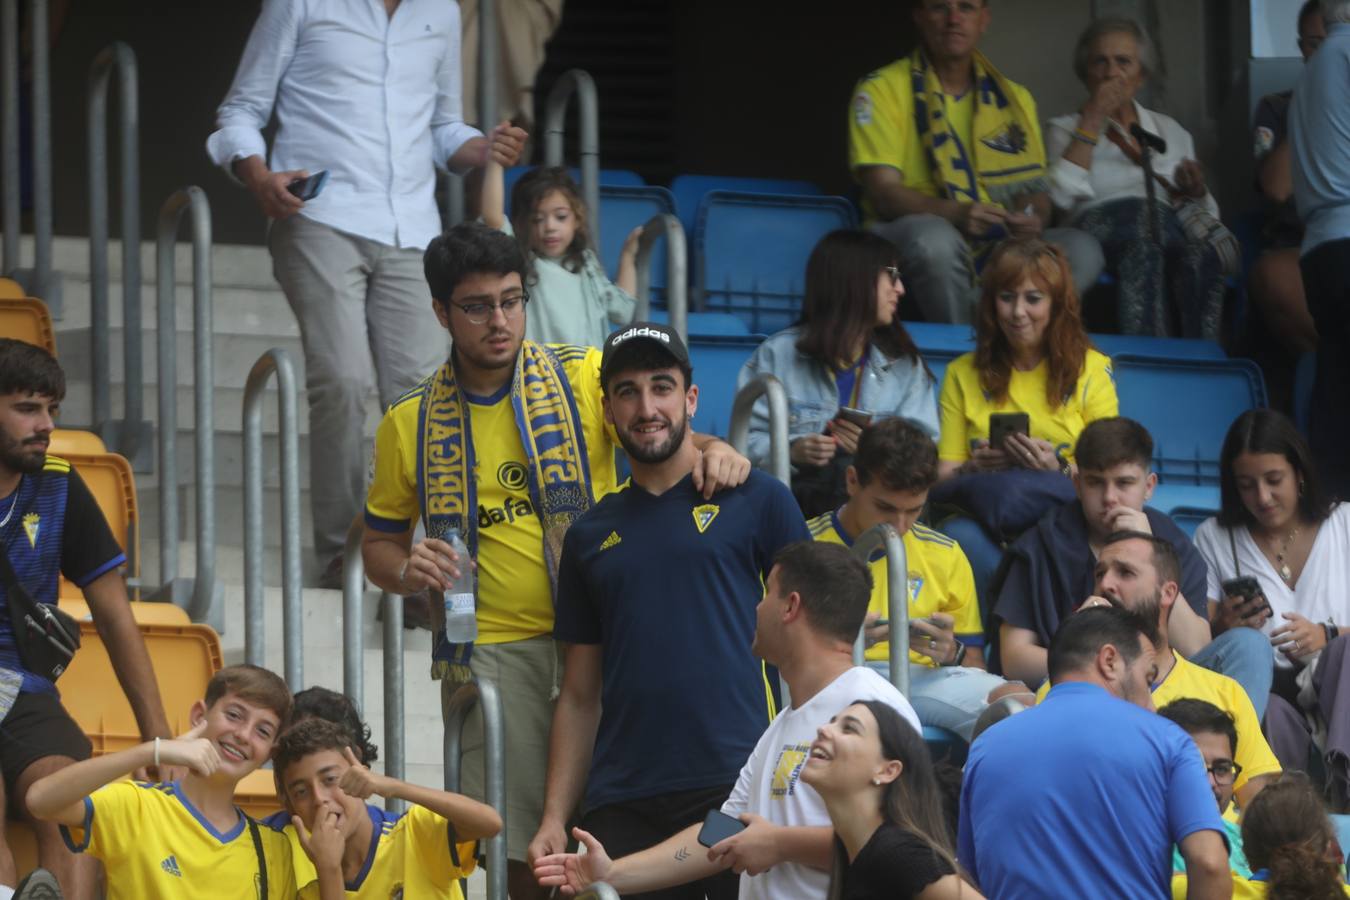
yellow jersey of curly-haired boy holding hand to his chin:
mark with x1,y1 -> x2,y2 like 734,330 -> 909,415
285,804 -> 478,900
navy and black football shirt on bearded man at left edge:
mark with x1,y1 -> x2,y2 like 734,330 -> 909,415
0,456 -> 127,692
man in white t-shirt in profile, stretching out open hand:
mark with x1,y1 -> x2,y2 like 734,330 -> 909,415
535,541 -> 921,900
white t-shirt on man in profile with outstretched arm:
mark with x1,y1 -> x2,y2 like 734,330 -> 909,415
722,667 -> 923,900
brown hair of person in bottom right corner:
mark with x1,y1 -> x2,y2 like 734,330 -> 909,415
1242,772 -> 1345,900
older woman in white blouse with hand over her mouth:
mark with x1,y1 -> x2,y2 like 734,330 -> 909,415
1045,19 -> 1224,337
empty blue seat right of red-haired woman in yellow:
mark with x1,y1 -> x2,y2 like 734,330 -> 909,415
1112,354 -> 1266,488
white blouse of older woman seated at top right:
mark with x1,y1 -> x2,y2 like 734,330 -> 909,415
1045,103 -> 1219,221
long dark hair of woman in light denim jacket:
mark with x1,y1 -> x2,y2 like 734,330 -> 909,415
797,228 -> 922,368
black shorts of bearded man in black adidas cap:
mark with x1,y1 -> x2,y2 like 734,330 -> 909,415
582,785 -> 741,900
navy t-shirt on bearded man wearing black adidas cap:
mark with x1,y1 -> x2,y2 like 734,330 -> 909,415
554,470 -> 811,810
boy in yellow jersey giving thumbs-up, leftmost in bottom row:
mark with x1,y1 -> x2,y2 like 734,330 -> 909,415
27,665 -> 334,900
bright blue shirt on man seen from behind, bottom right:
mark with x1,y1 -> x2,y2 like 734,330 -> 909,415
957,681 -> 1224,900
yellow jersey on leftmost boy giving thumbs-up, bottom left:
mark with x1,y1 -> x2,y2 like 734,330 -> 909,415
61,781 -> 296,900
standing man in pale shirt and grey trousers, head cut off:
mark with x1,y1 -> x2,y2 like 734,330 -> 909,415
207,0 -> 525,577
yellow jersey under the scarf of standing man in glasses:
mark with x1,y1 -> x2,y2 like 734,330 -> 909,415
366,344 -> 618,644
